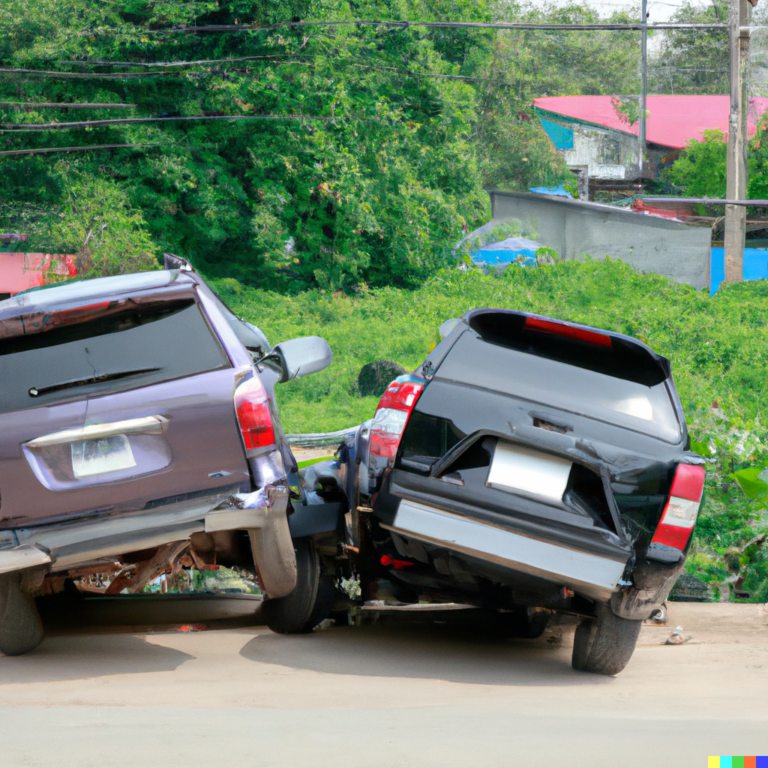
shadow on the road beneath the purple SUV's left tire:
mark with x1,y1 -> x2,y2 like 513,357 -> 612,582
0,635 -> 193,688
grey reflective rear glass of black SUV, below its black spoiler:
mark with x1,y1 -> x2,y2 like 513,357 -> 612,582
436,332 -> 681,443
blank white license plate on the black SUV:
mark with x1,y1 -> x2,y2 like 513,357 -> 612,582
486,441 -> 572,502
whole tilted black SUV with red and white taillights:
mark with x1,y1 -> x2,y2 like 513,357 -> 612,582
346,309 -> 705,675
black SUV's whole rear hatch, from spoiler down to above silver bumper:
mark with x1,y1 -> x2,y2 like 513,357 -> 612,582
391,310 -> 687,557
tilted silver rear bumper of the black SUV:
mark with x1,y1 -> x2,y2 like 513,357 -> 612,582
382,499 -> 628,602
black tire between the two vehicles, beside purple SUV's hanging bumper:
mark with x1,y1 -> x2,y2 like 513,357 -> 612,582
262,538 -> 336,635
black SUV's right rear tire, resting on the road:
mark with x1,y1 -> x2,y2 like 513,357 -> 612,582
571,604 -> 643,675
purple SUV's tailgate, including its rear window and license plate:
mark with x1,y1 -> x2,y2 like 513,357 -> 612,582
0,284 -> 249,527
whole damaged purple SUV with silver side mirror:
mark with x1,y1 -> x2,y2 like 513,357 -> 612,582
0,255 -> 336,654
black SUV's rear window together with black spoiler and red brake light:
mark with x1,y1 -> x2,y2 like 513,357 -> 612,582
435,310 -> 682,444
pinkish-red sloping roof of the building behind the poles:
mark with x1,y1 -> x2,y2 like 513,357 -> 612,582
533,96 -> 768,149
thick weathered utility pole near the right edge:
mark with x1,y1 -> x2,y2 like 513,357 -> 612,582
724,0 -> 751,283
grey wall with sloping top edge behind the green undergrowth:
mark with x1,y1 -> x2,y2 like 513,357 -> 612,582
490,192 -> 712,290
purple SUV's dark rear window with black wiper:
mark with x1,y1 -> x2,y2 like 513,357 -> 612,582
0,299 -> 229,413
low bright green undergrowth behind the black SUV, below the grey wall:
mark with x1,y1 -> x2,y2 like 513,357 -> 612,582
215,260 -> 768,600
